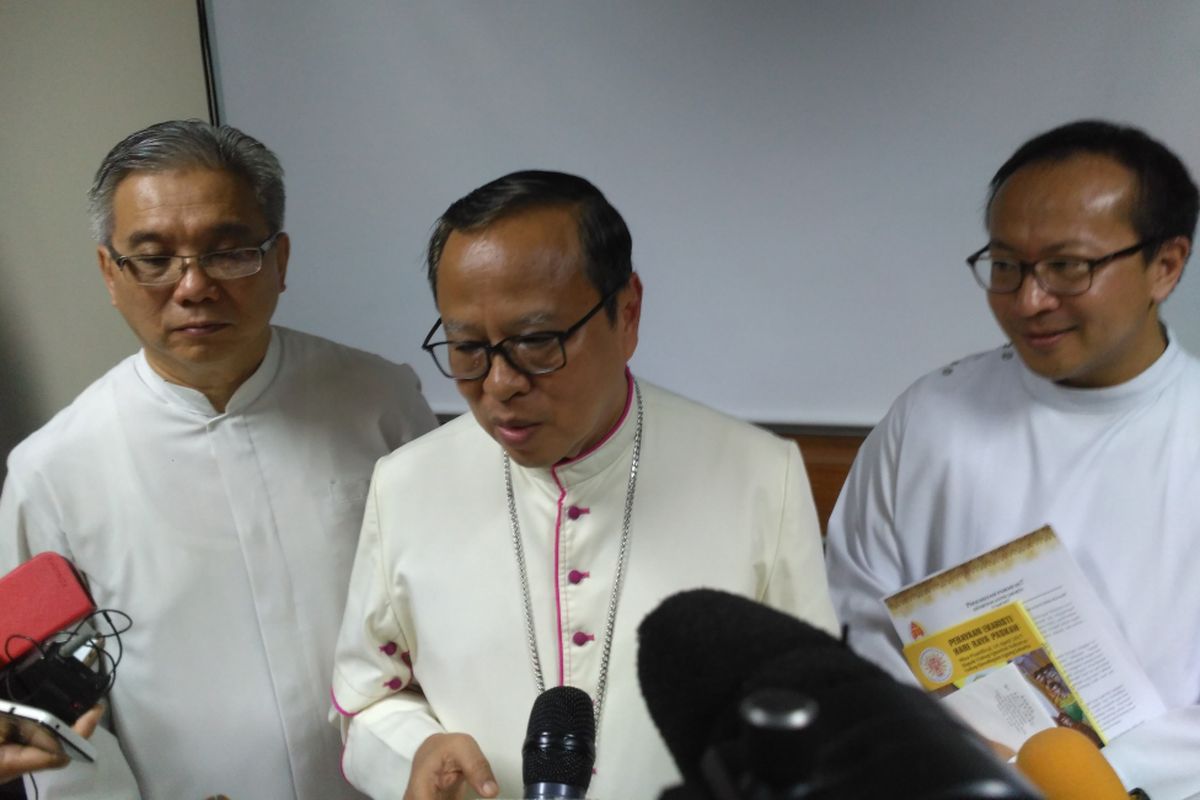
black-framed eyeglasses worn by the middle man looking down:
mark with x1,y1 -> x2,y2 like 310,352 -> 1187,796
421,289 -> 619,380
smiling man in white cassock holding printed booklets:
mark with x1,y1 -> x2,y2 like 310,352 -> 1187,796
828,121 -> 1200,800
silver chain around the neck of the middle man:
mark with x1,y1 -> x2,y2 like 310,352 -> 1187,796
504,380 -> 642,730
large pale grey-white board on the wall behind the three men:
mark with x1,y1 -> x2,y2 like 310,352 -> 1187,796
210,0 -> 1200,425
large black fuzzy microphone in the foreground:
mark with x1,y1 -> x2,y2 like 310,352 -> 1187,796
637,589 -> 1039,800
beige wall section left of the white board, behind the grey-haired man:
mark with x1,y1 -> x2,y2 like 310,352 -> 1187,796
0,0 -> 208,473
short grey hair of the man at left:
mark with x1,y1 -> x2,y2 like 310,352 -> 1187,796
88,119 -> 284,245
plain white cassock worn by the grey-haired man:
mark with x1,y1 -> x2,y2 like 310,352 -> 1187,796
0,327 -> 436,800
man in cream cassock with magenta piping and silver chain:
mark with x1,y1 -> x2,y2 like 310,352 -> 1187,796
334,172 -> 836,800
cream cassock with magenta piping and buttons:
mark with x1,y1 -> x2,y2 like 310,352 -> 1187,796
334,381 -> 836,800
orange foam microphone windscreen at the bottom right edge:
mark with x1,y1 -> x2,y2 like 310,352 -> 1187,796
1016,728 -> 1129,800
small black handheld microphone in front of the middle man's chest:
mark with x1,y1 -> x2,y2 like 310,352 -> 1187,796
521,686 -> 596,800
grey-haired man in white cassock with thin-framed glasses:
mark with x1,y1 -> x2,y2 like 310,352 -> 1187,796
0,120 -> 436,800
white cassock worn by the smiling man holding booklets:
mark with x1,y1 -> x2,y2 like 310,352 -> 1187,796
828,342 -> 1200,800
